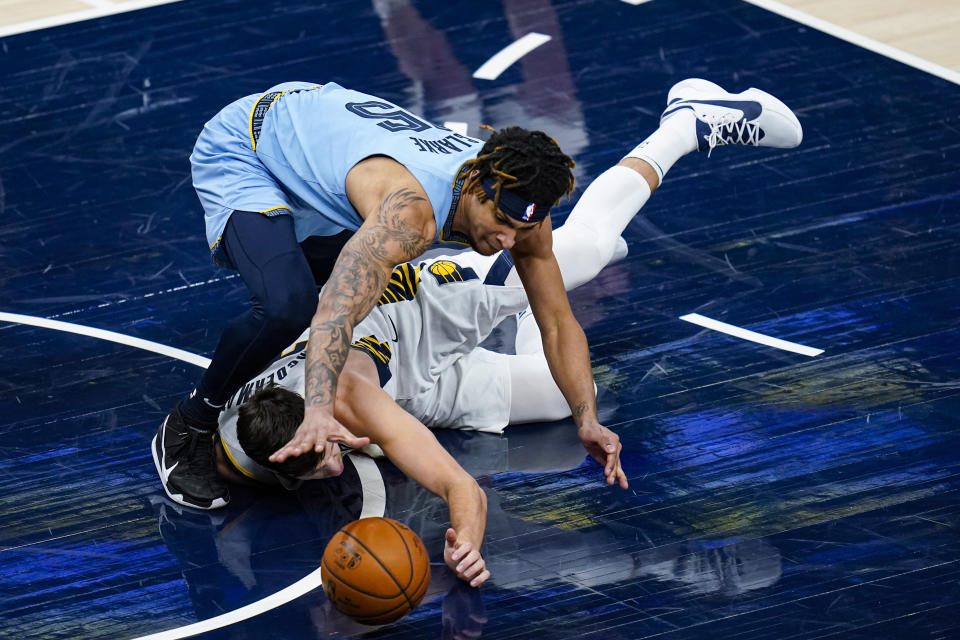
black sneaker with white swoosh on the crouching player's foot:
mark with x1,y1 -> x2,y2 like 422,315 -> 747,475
151,403 -> 230,509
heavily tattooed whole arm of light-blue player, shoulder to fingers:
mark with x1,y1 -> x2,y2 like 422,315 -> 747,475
270,156 -> 436,462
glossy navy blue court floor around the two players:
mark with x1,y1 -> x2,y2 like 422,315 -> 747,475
0,0 -> 960,640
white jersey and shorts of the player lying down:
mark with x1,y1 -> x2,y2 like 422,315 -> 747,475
220,252 -> 528,484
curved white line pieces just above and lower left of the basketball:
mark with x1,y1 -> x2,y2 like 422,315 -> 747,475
134,455 -> 386,640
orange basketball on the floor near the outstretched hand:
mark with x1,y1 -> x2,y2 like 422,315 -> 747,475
321,518 -> 430,624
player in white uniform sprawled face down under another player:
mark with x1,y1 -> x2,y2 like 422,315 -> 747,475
210,80 -> 802,585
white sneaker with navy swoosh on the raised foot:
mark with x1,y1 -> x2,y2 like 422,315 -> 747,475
660,78 -> 803,155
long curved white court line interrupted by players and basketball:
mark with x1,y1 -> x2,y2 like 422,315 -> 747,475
0,311 -> 387,640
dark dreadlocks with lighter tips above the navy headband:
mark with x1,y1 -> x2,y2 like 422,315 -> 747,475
461,125 -> 575,207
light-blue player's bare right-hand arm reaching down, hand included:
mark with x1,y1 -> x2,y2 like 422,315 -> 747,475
510,219 -> 628,489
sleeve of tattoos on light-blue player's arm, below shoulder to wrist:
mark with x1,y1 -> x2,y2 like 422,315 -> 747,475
304,189 -> 432,408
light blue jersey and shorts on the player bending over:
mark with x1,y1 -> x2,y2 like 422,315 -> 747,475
190,82 -> 483,267
